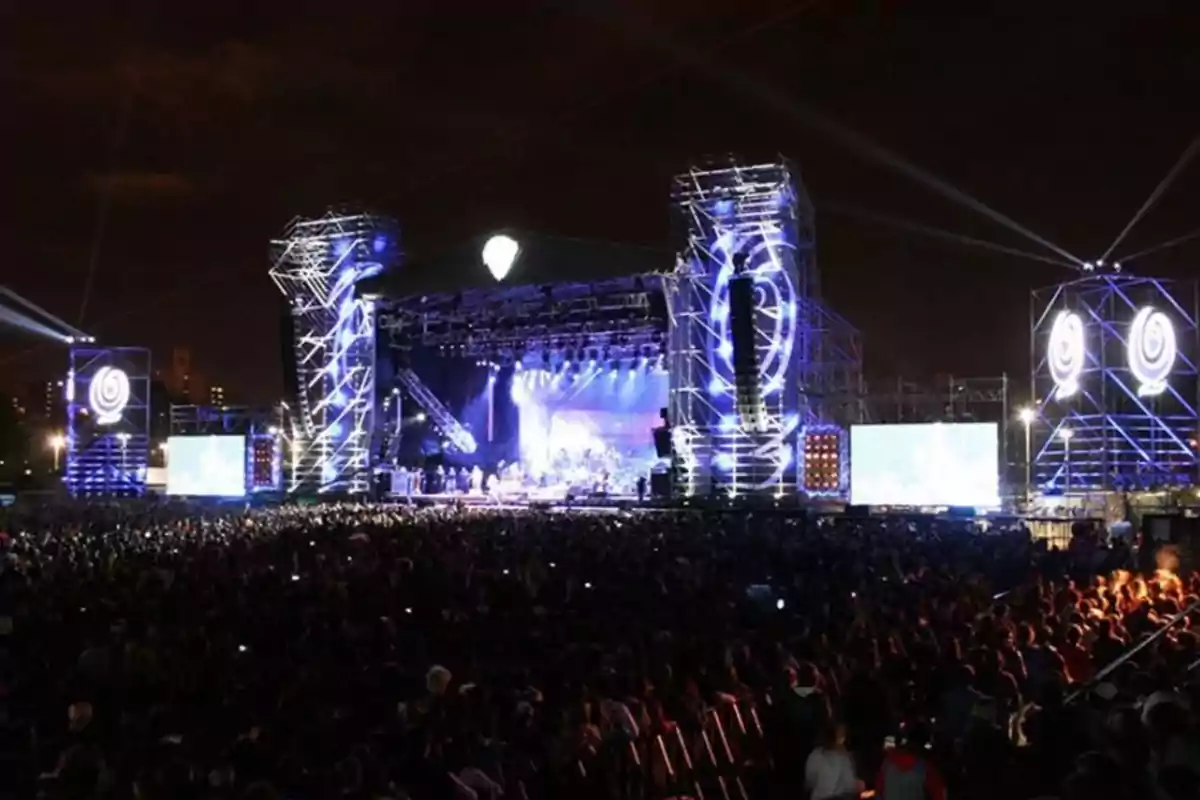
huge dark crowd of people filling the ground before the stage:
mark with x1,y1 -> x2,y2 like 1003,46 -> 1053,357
0,504 -> 1200,800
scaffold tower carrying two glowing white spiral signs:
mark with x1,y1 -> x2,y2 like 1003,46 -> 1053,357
1030,272 -> 1200,492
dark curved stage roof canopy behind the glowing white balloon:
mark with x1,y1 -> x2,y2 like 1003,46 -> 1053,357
358,230 -> 674,299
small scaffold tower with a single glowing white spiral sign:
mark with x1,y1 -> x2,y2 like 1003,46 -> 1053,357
65,347 -> 151,497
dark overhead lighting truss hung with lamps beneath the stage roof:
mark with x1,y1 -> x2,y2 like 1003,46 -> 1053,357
379,273 -> 667,367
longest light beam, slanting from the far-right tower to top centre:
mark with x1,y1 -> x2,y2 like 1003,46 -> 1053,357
572,4 -> 1084,266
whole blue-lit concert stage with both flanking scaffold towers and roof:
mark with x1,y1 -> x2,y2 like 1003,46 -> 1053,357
271,158 -> 862,498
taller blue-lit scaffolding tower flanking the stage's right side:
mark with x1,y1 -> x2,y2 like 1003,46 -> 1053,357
666,163 -> 817,497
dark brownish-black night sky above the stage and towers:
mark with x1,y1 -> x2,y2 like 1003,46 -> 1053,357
0,0 -> 1200,402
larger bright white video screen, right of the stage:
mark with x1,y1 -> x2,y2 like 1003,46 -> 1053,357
850,422 -> 1000,507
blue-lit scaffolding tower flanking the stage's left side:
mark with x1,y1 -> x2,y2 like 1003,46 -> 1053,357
270,210 -> 401,494
